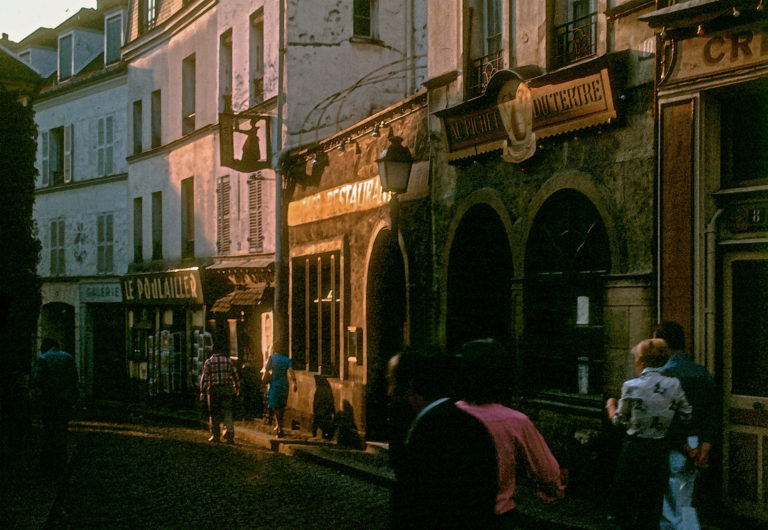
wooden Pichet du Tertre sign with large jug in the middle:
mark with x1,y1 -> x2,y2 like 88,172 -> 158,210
436,64 -> 617,162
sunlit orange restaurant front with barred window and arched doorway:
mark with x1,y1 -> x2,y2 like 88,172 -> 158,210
286,93 -> 430,442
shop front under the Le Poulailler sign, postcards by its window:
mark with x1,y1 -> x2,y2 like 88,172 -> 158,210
120,268 -> 212,399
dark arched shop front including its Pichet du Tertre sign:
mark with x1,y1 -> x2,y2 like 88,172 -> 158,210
433,53 -> 654,495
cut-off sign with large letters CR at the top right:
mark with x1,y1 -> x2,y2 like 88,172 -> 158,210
667,26 -> 768,82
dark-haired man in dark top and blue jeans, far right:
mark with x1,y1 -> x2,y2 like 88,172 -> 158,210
653,320 -> 718,530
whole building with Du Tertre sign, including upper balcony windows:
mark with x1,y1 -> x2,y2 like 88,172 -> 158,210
425,0 -> 656,494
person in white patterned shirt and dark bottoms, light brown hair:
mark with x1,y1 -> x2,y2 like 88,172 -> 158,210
605,339 -> 692,529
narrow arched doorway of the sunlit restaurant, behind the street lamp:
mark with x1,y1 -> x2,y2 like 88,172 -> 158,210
365,230 -> 407,440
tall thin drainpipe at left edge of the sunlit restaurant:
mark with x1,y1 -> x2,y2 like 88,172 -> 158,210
272,0 -> 288,355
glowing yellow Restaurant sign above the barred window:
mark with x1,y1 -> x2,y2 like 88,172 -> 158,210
288,177 -> 392,226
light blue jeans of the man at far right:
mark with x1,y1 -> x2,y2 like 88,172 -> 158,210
660,449 -> 699,530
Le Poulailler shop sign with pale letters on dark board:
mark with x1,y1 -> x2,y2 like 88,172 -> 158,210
120,268 -> 203,305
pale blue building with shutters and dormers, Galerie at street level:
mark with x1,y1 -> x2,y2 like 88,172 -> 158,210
24,1 -> 128,397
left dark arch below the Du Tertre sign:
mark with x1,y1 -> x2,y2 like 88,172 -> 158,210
445,204 -> 513,352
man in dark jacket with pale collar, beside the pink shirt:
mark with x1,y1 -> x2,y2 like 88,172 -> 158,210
390,350 -> 498,529
